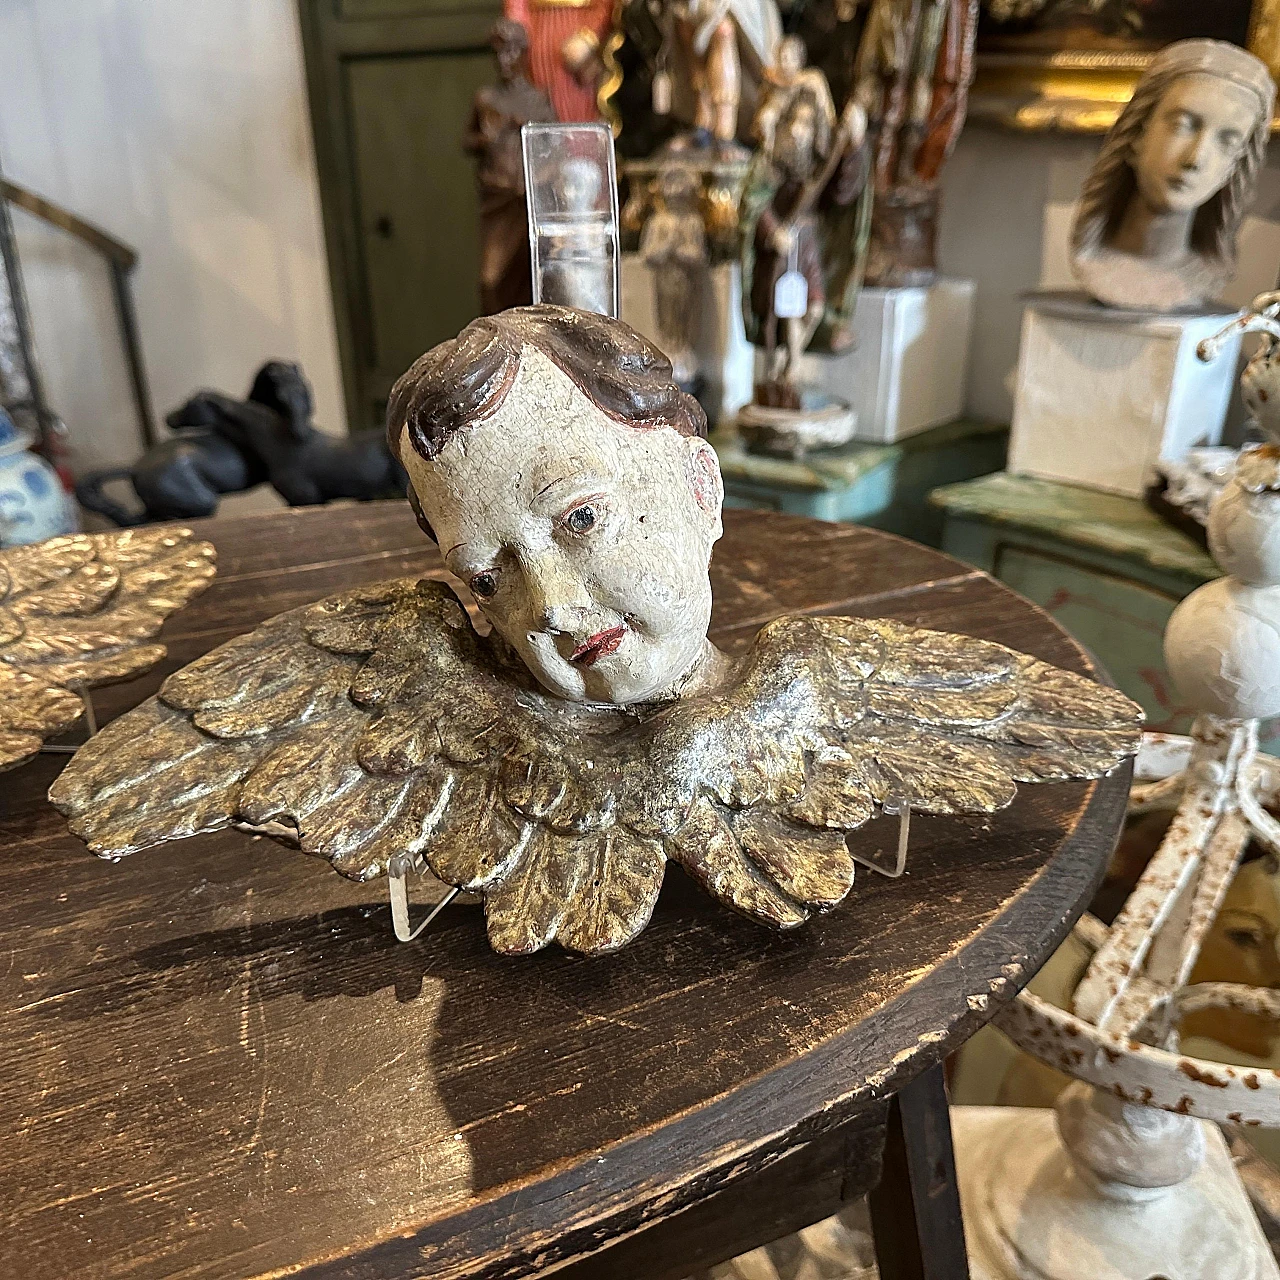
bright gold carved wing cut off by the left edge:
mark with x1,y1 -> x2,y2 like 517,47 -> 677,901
0,527 -> 215,771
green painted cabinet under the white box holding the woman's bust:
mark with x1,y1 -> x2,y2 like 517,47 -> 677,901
932,472 -> 1280,753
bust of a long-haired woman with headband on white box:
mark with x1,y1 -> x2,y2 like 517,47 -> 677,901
1071,40 -> 1275,311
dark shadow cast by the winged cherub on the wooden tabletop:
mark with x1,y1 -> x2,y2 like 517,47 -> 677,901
24,808 -> 1008,1192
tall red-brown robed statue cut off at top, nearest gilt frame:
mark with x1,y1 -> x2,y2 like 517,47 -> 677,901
854,0 -> 978,287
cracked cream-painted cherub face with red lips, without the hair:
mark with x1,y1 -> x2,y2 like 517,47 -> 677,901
401,348 -> 723,705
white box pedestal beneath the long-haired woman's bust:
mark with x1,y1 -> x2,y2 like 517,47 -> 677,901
1009,293 -> 1240,498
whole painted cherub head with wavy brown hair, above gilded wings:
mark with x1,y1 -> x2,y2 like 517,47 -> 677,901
388,306 -> 723,705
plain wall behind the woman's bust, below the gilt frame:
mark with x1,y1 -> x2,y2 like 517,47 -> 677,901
938,124 -> 1280,422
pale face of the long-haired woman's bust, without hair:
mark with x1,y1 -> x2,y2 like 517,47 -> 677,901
1133,74 -> 1258,214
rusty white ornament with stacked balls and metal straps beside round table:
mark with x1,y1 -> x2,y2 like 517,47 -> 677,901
956,294 -> 1280,1280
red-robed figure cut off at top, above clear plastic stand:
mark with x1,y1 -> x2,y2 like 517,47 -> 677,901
503,0 -> 613,124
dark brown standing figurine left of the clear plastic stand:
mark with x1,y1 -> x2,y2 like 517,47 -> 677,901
462,18 -> 556,315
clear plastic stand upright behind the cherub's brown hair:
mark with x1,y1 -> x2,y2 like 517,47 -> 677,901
520,124 -> 621,319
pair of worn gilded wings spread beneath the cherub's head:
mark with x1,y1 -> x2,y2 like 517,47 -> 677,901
50,579 -> 1142,954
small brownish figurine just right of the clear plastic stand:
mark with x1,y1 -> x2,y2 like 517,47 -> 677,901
640,161 -> 708,390
